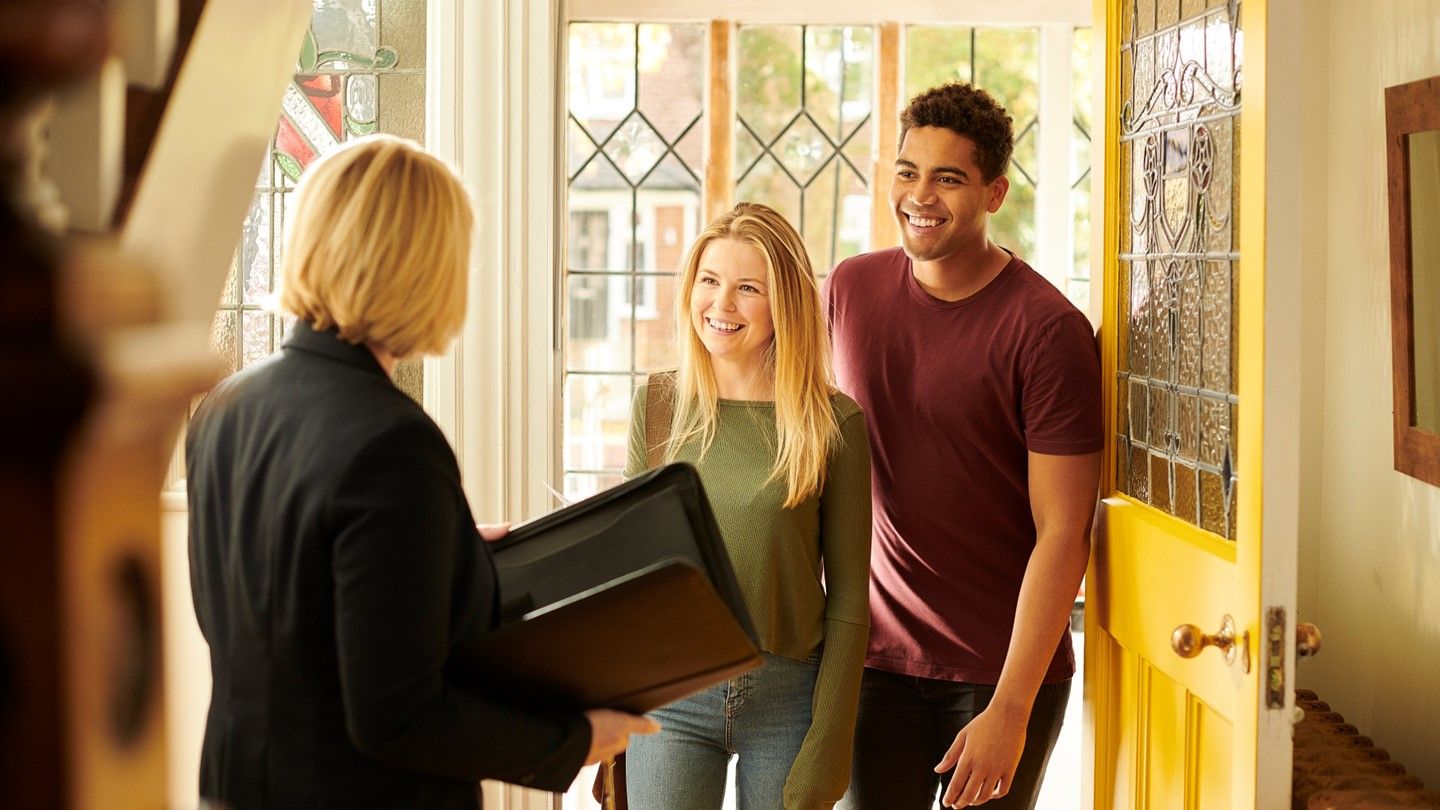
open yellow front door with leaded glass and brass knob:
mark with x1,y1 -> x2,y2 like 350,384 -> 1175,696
1084,0 -> 1296,810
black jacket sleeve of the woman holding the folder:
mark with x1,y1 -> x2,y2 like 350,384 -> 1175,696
324,419 -> 590,790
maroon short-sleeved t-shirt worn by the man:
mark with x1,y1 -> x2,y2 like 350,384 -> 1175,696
825,248 -> 1103,683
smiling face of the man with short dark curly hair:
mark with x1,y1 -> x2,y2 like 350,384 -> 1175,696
890,127 -> 1009,262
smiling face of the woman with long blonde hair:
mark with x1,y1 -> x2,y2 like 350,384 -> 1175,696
690,239 -> 775,373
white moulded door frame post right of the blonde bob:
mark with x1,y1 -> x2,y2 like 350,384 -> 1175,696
425,0 -> 563,530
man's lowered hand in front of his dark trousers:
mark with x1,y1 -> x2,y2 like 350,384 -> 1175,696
935,703 -> 1030,807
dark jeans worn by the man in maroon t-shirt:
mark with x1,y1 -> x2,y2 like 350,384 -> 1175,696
840,667 -> 1070,810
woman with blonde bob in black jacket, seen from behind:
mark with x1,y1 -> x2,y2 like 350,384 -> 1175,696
186,137 -> 652,810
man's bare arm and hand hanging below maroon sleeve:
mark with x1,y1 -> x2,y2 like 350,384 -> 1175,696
936,443 -> 1100,807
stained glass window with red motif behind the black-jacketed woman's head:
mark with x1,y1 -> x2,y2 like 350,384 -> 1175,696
210,0 -> 425,401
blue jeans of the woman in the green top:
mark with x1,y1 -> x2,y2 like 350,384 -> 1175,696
625,653 -> 819,810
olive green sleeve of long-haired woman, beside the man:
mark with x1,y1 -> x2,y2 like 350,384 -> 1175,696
785,411 -> 870,809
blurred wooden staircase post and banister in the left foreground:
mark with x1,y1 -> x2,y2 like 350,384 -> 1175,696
0,0 -> 311,809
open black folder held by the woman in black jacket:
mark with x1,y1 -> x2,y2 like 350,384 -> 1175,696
461,464 -> 760,712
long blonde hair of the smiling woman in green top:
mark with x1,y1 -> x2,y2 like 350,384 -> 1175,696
665,203 -> 840,507
